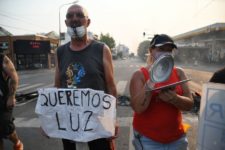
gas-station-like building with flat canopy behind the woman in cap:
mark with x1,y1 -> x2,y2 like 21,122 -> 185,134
173,23 -> 225,65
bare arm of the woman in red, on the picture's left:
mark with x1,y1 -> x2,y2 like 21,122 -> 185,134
130,71 -> 151,113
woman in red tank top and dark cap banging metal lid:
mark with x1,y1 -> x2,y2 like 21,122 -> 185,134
130,34 -> 193,150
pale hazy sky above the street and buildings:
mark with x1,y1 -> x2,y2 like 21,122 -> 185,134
0,0 -> 225,51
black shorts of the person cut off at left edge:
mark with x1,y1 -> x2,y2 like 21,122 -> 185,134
0,109 -> 15,139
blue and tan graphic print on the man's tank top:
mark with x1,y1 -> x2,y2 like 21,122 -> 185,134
66,62 -> 86,88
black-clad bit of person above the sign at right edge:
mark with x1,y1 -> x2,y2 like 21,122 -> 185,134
209,67 -> 225,84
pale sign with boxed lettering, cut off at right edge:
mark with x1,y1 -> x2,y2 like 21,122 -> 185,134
197,83 -> 225,150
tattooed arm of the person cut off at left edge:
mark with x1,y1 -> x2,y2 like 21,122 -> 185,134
3,56 -> 19,107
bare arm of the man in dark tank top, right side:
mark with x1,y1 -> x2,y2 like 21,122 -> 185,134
103,45 -> 117,97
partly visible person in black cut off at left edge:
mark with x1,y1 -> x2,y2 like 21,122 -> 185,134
0,54 -> 23,150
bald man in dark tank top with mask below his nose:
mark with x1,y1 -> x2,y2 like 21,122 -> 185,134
52,4 -> 117,150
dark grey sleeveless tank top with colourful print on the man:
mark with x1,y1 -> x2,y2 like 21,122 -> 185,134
57,41 -> 106,92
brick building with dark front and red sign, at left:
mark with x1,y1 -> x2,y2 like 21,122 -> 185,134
0,29 -> 59,70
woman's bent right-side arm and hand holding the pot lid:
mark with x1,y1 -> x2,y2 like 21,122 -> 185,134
159,68 -> 194,111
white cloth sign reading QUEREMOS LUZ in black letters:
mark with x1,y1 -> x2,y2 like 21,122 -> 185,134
35,88 -> 116,142
